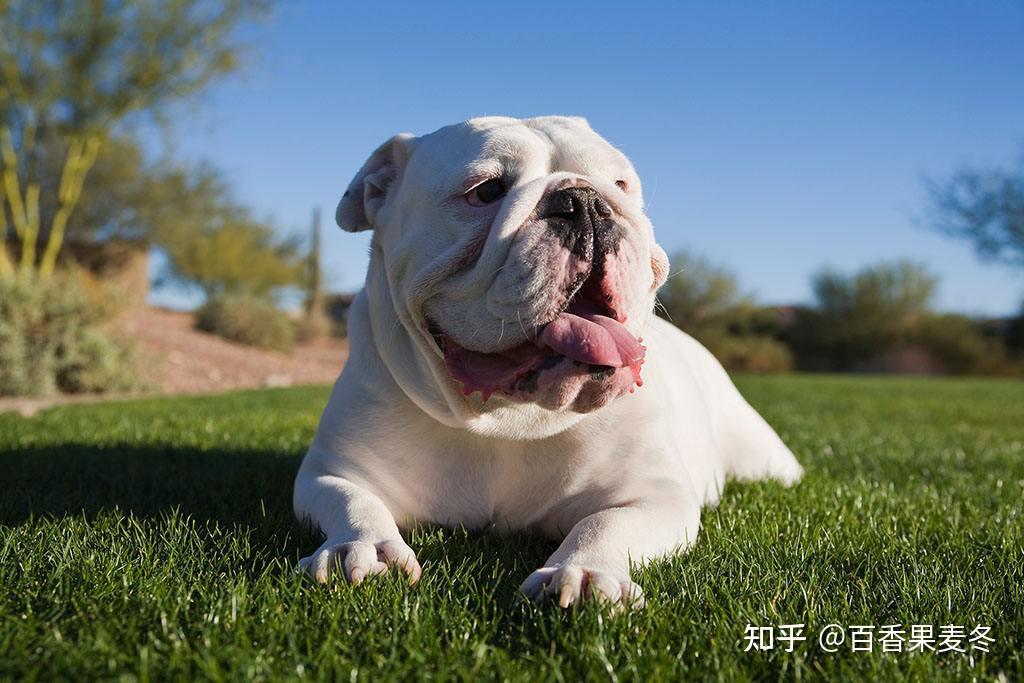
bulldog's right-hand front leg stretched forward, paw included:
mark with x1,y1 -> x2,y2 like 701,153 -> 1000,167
520,485 -> 700,607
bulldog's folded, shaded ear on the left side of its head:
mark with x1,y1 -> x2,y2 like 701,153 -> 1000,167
334,133 -> 415,232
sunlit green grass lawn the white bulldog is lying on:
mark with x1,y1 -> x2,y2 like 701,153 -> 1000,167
0,377 -> 1024,681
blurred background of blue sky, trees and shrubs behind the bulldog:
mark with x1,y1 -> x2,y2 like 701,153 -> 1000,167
0,0 -> 1024,403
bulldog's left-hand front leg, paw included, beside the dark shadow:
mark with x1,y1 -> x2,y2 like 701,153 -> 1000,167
294,463 -> 421,584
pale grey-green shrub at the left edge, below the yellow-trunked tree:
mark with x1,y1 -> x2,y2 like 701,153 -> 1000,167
0,273 -> 140,395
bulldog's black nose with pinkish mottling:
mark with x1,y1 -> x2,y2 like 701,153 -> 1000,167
538,187 -> 618,265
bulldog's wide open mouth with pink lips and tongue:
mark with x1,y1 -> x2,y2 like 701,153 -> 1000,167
428,268 -> 646,408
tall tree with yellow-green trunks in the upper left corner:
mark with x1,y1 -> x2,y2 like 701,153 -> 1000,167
0,0 -> 264,279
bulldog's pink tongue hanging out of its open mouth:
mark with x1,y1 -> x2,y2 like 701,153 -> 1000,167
537,311 -> 645,370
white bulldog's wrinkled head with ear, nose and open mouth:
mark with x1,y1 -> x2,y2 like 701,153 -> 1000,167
338,117 -> 668,413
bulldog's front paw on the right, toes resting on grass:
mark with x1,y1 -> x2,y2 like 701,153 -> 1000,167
519,564 -> 644,609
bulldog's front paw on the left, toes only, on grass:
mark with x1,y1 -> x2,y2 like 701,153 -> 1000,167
299,539 -> 423,586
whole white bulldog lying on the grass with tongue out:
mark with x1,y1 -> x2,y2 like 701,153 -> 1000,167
294,117 -> 801,607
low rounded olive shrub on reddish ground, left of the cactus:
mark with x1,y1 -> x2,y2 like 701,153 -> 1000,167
196,295 -> 295,351
